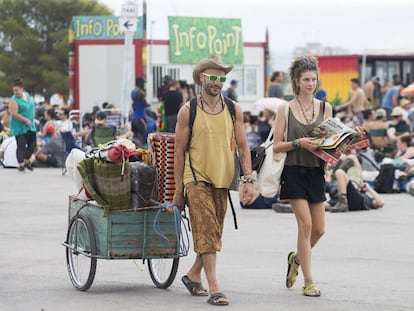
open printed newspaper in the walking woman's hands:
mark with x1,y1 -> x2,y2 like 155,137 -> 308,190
309,118 -> 369,165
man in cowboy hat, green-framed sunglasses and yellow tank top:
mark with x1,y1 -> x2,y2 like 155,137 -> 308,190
173,55 -> 256,305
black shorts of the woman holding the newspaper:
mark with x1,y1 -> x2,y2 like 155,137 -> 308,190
280,165 -> 326,203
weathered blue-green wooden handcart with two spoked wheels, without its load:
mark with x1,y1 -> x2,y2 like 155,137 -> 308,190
62,196 -> 188,291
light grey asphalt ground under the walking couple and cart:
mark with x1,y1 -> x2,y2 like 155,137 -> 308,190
0,168 -> 414,311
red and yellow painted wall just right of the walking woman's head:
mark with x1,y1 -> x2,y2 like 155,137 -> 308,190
318,55 -> 360,105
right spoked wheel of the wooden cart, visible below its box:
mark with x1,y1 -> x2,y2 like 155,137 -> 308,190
148,257 -> 180,288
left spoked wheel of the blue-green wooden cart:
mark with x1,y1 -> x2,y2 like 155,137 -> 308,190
66,215 -> 96,291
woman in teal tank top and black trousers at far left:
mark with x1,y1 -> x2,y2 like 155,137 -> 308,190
9,78 -> 36,172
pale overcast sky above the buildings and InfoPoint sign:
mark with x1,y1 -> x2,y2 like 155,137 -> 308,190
98,0 -> 414,71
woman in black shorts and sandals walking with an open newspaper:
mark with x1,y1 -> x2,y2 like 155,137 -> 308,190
273,56 -> 332,297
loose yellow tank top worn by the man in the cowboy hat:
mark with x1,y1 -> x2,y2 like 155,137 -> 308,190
184,103 -> 235,188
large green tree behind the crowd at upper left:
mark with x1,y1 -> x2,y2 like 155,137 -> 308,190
0,0 -> 113,98
